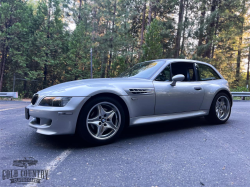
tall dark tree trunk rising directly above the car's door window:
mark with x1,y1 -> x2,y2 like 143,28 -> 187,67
174,0 -> 184,58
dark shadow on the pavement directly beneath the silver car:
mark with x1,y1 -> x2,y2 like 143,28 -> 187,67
29,117 -> 211,149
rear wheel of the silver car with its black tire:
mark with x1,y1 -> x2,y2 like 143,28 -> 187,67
205,93 -> 232,124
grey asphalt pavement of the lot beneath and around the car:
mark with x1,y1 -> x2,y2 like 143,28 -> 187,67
0,101 -> 250,187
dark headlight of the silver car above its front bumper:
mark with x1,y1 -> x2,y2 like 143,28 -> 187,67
39,97 -> 72,107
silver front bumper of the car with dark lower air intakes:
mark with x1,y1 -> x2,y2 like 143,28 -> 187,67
26,97 -> 88,135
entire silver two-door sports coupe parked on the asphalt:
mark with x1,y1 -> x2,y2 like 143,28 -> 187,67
25,59 -> 233,145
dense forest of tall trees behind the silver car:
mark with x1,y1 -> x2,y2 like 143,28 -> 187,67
0,0 -> 250,97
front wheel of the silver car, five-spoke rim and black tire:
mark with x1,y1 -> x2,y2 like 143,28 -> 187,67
76,97 -> 125,145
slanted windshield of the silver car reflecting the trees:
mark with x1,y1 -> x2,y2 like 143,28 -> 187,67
118,61 -> 165,79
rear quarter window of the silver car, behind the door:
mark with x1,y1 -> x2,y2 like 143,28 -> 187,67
196,64 -> 220,81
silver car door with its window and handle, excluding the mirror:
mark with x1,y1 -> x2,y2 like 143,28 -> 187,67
153,62 -> 204,115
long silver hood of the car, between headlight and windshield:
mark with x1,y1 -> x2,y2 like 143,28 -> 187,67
38,78 -> 153,96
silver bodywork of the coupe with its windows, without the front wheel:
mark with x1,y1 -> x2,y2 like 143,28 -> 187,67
26,59 -> 232,145
